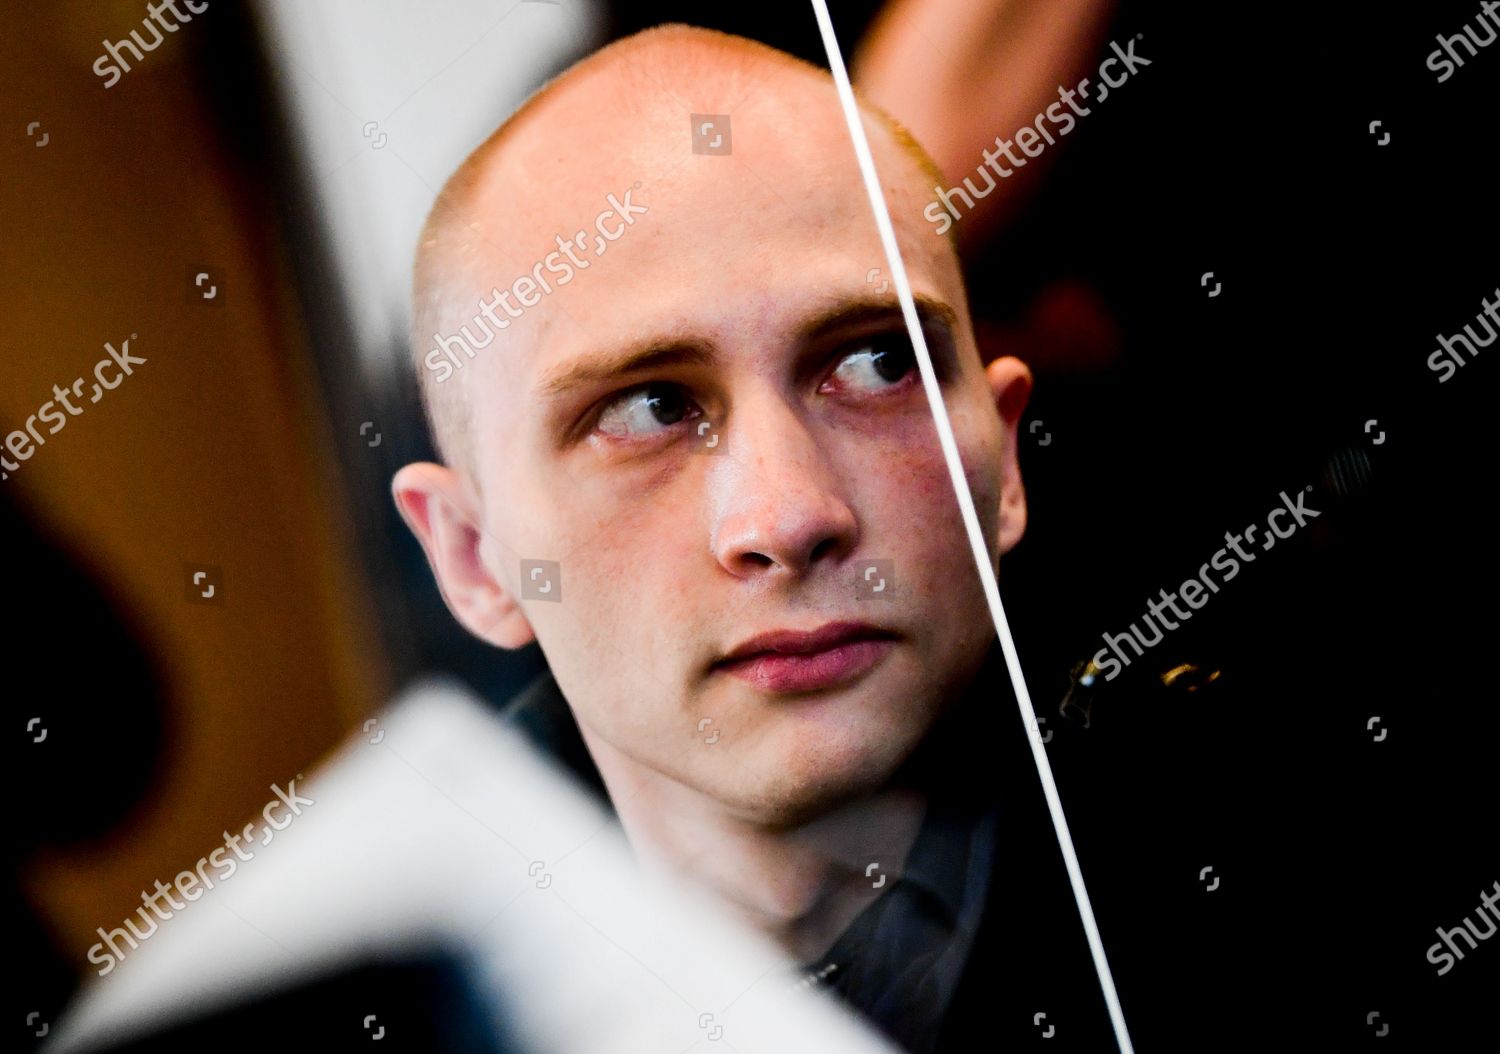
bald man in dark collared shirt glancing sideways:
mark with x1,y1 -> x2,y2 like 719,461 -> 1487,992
393,27 -> 1116,1051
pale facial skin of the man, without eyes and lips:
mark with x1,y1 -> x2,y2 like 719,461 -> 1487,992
398,37 -> 1029,826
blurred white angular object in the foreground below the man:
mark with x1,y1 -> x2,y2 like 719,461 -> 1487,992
47,682 -> 894,1054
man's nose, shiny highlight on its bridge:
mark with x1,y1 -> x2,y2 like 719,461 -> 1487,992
710,399 -> 860,580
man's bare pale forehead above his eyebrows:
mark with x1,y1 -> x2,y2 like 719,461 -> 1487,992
450,63 -> 965,450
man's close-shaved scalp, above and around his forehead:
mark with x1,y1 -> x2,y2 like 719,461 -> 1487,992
411,25 -> 951,481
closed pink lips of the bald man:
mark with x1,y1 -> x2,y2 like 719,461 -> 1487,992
711,622 -> 897,693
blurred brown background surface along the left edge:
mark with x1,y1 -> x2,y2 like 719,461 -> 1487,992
0,1 -> 386,972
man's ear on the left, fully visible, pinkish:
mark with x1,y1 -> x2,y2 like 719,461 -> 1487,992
392,462 -> 536,648
